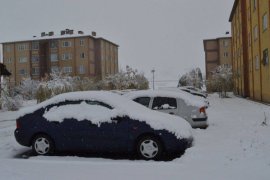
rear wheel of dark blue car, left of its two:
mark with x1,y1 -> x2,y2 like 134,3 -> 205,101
32,134 -> 54,155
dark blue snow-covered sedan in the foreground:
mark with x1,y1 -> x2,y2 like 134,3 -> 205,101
14,91 -> 193,159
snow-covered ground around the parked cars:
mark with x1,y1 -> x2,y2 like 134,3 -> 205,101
0,95 -> 270,180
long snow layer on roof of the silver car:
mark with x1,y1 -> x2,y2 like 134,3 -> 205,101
124,90 -> 205,107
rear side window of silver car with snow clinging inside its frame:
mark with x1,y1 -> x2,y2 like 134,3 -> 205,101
152,97 -> 177,110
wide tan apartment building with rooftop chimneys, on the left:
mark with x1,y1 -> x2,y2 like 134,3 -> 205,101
2,29 -> 118,84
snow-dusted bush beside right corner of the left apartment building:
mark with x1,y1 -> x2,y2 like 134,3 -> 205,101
99,66 -> 149,90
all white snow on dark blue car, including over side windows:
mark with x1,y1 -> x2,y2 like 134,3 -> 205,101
19,91 -> 192,139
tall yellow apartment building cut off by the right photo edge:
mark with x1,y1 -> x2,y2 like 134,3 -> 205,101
229,0 -> 270,103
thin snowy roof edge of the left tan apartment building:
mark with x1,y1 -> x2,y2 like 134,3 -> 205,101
1,34 -> 119,47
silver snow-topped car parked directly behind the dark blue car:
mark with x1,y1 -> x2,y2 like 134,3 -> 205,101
124,90 -> 208,128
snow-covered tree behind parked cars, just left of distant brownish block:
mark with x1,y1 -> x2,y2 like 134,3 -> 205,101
178,68 -> 203,88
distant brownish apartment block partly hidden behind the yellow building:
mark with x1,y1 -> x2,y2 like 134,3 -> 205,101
203,37 -> 232,80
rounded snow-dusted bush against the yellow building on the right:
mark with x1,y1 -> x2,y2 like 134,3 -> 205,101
207,64 -> 233,97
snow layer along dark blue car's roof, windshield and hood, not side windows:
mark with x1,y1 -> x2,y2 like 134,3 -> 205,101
19,91 -> 191,139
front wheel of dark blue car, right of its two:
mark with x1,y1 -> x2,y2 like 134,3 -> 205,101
137,136 -> 162,160
